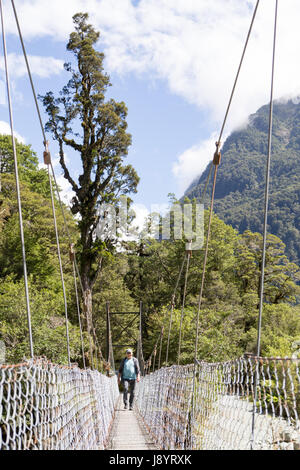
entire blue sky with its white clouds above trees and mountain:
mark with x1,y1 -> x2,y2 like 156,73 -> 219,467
0,0 -> 300,222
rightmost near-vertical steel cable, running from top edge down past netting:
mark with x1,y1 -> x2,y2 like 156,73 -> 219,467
251,0 -> 278,449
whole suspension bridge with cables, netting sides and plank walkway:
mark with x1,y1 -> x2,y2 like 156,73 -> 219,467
0,0 -> 300,450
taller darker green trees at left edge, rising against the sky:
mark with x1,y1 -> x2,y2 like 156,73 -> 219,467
0,170 -> 76,282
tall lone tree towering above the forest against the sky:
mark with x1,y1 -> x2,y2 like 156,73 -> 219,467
42,13 -> 139,338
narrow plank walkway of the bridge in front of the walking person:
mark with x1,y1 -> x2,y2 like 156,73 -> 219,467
106,395 -> 157,450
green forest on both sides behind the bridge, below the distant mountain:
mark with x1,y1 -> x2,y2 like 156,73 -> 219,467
0,136 -> 300,367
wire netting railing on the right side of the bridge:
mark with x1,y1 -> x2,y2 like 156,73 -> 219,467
137,356 -> 300,450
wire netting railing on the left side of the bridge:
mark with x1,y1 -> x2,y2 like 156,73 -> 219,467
0,359 -> 119,450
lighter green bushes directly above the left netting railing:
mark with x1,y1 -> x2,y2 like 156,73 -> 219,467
0,278 -> 87,364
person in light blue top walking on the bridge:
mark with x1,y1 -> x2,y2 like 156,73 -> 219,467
118,349 -> 141,410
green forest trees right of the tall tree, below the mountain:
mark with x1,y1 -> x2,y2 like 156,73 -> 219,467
125,207 -> 300,363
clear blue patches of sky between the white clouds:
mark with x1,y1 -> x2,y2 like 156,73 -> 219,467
0,17 -> 209,209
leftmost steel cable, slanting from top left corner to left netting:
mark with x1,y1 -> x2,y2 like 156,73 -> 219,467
0,0 -> 34,359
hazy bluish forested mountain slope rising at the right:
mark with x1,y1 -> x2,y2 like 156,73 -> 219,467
186,101 -> 300,263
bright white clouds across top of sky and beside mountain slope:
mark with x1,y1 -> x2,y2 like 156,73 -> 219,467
7,0 -> 300,191
